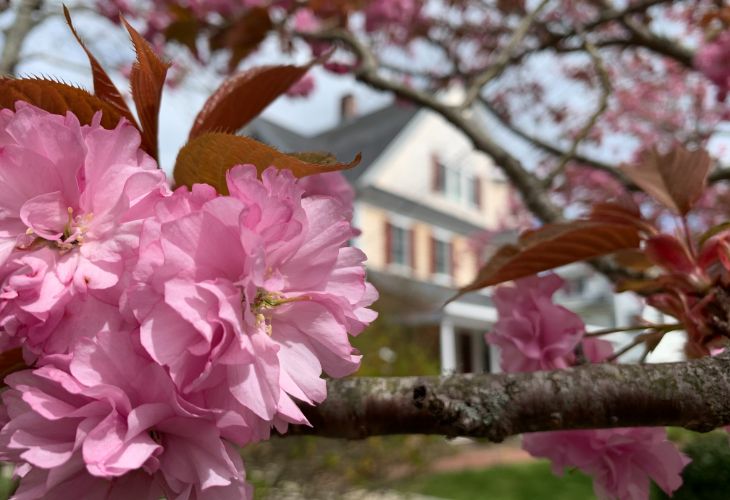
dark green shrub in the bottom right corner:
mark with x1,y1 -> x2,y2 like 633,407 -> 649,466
652,431 -> 730,500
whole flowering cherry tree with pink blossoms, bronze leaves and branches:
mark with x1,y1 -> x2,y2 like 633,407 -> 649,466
0,0 -> 730,499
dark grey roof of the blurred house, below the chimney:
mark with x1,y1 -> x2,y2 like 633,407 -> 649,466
243,103 -> 419,182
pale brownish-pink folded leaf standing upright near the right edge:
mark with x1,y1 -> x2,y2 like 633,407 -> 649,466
620,146 -> 712,215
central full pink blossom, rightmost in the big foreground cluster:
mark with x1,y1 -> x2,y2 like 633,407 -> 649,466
125,166 -> 376,444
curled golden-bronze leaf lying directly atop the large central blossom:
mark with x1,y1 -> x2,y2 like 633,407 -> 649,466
174,133 -> 360,194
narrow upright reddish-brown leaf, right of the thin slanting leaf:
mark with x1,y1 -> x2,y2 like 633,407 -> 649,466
122,18 -> 169,159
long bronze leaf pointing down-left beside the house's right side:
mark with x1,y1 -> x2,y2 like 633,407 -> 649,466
459,220 -> 641,295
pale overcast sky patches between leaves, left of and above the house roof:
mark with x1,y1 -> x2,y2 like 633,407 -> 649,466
5,7 -> 391,171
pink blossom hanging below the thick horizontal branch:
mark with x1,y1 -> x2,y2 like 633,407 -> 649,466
522,427 -> 690,500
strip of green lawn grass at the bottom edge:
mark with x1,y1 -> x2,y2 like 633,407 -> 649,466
392,461 -> 595,500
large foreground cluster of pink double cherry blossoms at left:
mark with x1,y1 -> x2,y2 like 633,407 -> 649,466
0,103 -> 377,500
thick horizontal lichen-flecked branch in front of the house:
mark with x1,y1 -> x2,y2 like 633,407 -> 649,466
289,356 -> 730,442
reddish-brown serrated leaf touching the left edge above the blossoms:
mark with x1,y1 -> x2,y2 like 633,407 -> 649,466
0,78 -> 123,129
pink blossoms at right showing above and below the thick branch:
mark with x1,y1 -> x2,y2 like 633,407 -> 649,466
486,274 -> 689,500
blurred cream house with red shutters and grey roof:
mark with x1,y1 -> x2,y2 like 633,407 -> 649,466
245,96 -> 640,372
